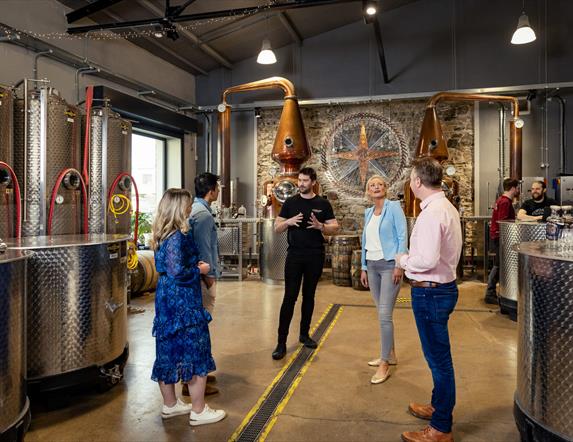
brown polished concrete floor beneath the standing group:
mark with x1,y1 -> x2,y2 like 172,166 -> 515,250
26,279 -> 519,442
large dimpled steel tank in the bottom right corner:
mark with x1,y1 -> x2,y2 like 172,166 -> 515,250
514,241 -> 573,442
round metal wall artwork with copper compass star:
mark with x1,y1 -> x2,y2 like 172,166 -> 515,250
321,113 -> 410,198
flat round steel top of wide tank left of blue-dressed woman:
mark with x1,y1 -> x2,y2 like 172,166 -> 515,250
7,233 -> 131,250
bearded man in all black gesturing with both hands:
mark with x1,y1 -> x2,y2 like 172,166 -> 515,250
273,167 -> 338,359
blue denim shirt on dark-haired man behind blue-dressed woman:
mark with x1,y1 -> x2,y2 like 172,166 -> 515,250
191,197 -> 220,278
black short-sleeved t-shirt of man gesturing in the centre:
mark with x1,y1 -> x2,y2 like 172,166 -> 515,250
279,195 -> 334,254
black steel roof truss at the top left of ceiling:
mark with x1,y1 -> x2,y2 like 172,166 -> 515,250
66,0 -> 358,40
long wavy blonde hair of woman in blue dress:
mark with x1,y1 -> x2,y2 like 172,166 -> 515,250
151,189 -> 193,250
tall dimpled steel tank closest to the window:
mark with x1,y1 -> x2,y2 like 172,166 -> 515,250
89,107 -> 132,234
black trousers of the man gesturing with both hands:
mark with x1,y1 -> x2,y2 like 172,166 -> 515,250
278,253 -> 324,343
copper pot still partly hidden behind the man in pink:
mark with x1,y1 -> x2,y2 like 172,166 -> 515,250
404,92 -> 523,217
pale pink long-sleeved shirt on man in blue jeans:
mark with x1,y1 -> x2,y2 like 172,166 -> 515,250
400,192 -> 462,283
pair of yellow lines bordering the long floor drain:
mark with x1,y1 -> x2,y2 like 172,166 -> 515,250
229,304 -> 342,442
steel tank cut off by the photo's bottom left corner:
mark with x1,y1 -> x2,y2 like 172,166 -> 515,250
0,249 -> 30,441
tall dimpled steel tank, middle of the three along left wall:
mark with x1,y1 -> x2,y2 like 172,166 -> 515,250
14,87 -> 82,236
